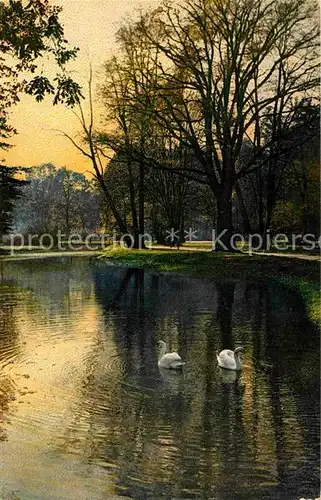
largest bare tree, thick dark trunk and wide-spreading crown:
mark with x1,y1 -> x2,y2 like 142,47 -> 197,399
126,0 -> 318,248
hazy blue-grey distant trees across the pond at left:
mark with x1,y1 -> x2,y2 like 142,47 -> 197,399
12,163 -> 100,237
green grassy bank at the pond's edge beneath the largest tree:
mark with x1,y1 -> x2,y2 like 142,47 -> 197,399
101,247 -> 321,321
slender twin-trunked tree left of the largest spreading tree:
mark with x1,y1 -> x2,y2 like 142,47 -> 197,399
99,25 -> 162,246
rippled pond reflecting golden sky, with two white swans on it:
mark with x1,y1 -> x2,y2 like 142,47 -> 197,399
0,257 -> 320,500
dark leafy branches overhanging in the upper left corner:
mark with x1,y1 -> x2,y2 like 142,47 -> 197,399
0,0 -> 81,121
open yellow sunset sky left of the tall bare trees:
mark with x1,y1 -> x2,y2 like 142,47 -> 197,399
4,0 -> 160,172
